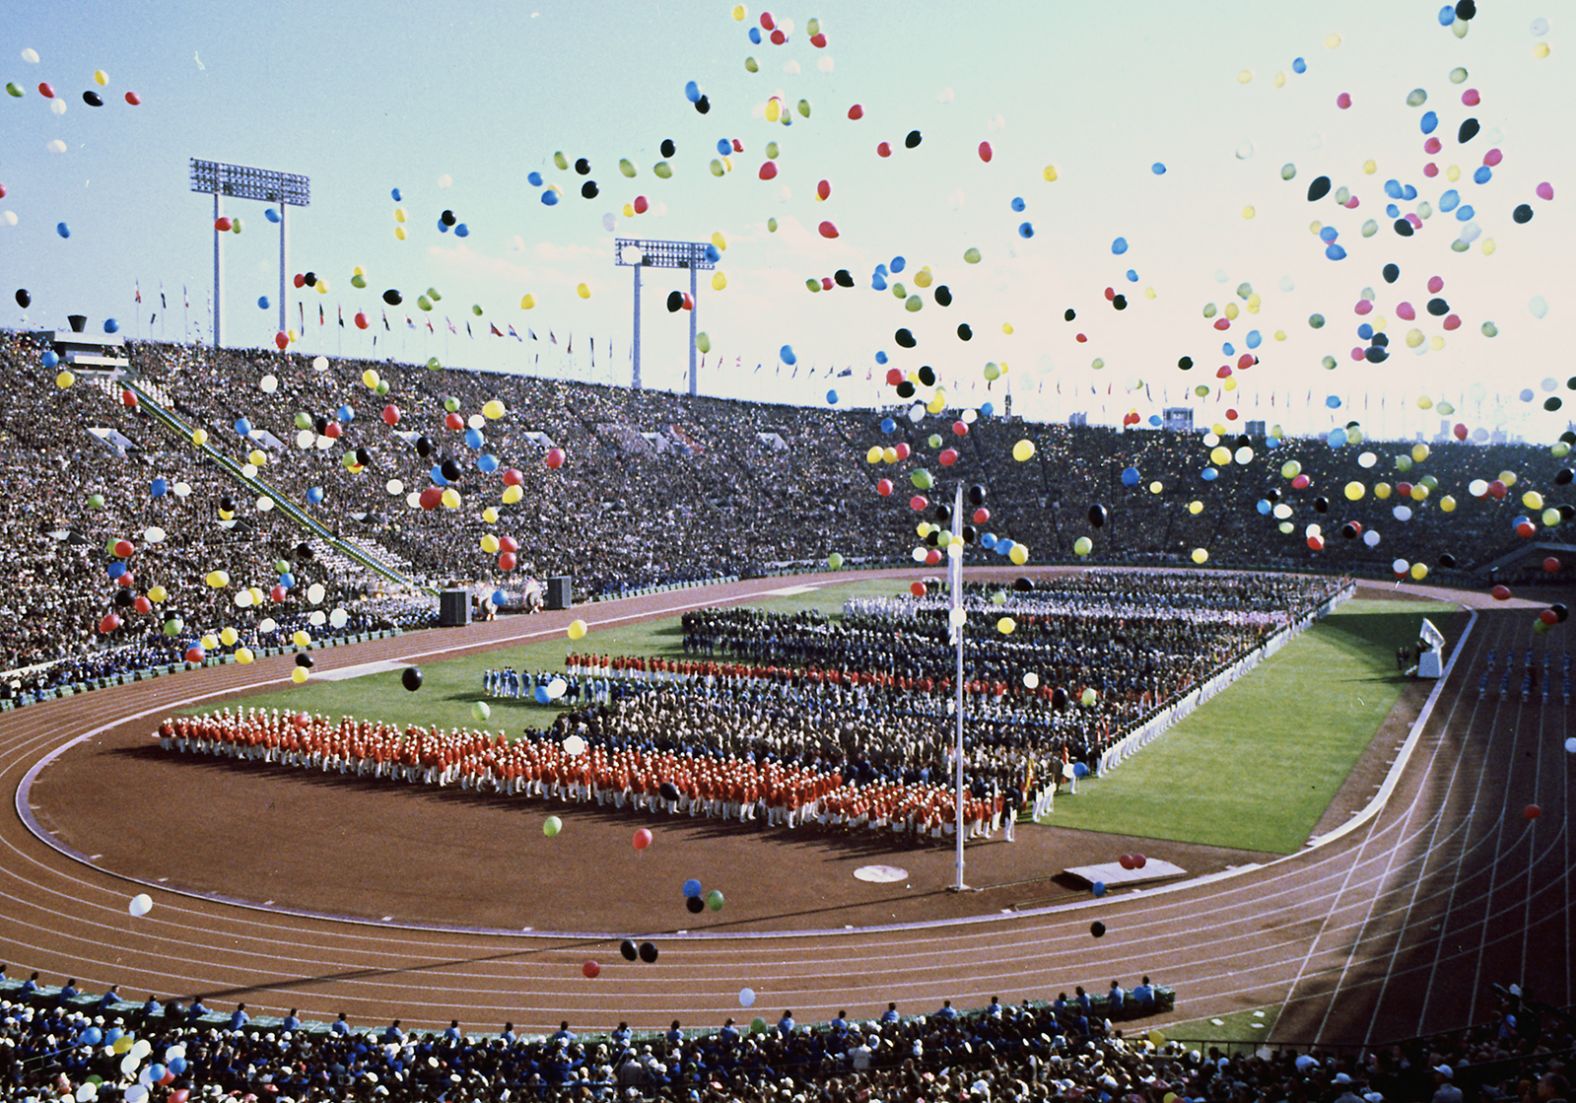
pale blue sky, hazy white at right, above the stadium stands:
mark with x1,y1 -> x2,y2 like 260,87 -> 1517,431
0,0 -> 1576,438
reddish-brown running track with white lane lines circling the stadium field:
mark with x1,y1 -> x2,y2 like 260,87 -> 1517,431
0,575 -> 1576,1042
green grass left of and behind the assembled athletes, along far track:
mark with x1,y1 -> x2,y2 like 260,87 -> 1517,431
188,578 -> 903,733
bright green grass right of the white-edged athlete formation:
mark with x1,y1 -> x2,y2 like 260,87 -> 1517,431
1040,600 -> 1455,854
